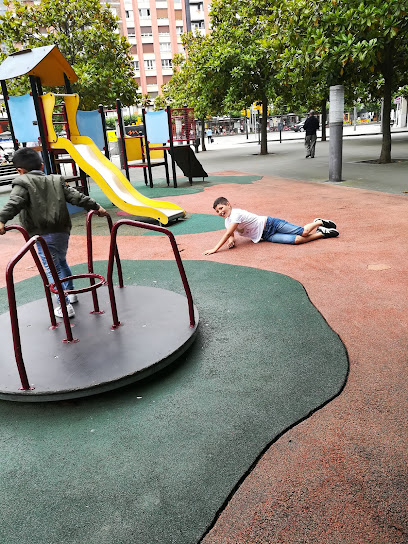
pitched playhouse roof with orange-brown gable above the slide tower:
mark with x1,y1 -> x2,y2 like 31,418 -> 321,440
0,45 -> 78,87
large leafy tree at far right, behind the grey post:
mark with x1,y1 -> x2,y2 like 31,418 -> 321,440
273,0 -> 408,162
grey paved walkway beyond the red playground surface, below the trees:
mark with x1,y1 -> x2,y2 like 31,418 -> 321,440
197,127 -> 408,194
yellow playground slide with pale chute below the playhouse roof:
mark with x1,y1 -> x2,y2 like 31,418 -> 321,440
41,93 -> 186,225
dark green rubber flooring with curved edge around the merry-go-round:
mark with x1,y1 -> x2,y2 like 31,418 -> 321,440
0,261 -> 348,544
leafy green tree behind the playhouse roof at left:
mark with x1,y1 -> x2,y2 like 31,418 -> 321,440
0,0 -> 138,109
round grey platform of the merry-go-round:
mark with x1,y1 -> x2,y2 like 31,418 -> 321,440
0,286 -> 198,402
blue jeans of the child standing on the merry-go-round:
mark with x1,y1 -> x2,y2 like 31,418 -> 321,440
36,232 -> 74,304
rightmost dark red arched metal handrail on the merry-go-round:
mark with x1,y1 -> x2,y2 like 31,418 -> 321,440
106,219 -> 195,329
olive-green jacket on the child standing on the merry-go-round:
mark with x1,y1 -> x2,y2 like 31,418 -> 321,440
0,170 -> 99,237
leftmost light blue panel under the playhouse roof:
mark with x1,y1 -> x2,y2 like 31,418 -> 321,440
8,94 -> 40,144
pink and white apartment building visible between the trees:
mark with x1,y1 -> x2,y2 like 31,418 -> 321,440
109,0 -> 210,98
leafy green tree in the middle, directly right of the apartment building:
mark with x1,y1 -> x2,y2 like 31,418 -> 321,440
164,0 -> 281,154
